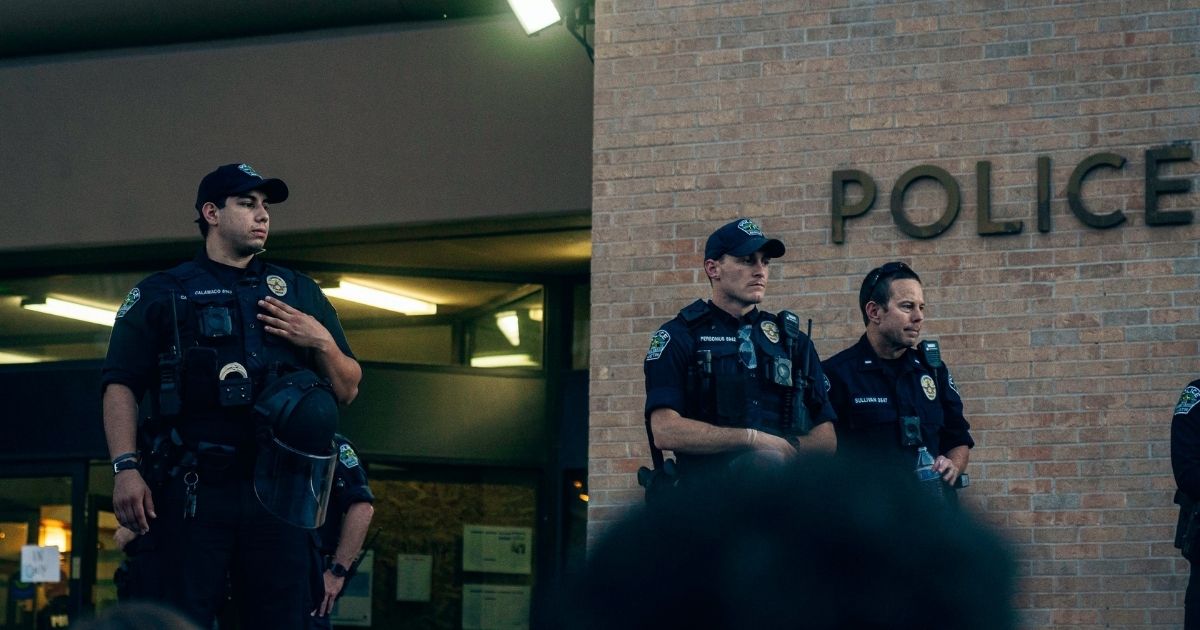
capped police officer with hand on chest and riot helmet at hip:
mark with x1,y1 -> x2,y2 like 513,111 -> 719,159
101,164 -> 362,628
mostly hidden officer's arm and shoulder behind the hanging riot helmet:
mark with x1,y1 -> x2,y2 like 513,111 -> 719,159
312,434 -> 374,629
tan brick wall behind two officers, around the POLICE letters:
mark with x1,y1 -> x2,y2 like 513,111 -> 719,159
588,0 -> 1200,628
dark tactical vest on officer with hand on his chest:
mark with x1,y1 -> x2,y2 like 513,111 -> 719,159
159,262 -> 307,446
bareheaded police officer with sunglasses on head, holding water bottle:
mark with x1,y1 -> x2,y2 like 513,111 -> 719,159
823,262 -> 974,492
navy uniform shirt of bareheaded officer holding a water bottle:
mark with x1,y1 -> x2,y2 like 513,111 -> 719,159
823,335 -> 974,468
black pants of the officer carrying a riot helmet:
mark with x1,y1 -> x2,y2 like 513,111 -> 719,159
150,476 -> 313,629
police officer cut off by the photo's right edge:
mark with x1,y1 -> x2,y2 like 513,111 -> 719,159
1171,379 -> 1200,630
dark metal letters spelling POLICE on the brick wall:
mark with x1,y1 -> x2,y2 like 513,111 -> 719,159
830,143 -> 1192,244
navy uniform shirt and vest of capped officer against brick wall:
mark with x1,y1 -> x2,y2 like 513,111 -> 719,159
643,300 -> 834,446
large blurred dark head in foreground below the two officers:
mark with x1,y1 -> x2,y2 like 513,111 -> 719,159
553,457 -> 1015,630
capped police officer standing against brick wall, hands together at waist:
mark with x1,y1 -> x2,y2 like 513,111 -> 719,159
638,218 -> 836,489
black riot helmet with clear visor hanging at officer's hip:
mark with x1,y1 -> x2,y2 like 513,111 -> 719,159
254,370 -> 337,529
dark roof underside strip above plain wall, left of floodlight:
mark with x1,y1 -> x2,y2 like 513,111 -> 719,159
0,0 -> 516,59
